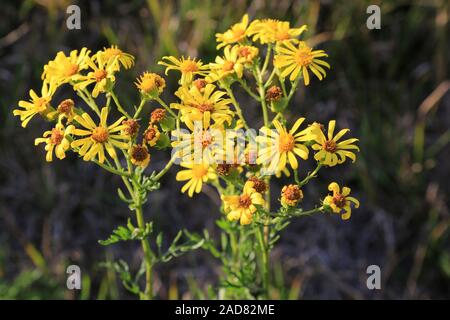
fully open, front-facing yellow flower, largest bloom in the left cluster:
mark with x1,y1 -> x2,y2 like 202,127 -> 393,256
71,107 -> 130,163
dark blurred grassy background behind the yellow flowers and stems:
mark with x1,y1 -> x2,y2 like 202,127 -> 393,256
0,0 -> 450,299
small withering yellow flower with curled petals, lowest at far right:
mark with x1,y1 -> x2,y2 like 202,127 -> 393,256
323,182 -> 359,220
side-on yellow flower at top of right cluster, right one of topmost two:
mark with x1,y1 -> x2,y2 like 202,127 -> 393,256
248,19 -> 307,44
